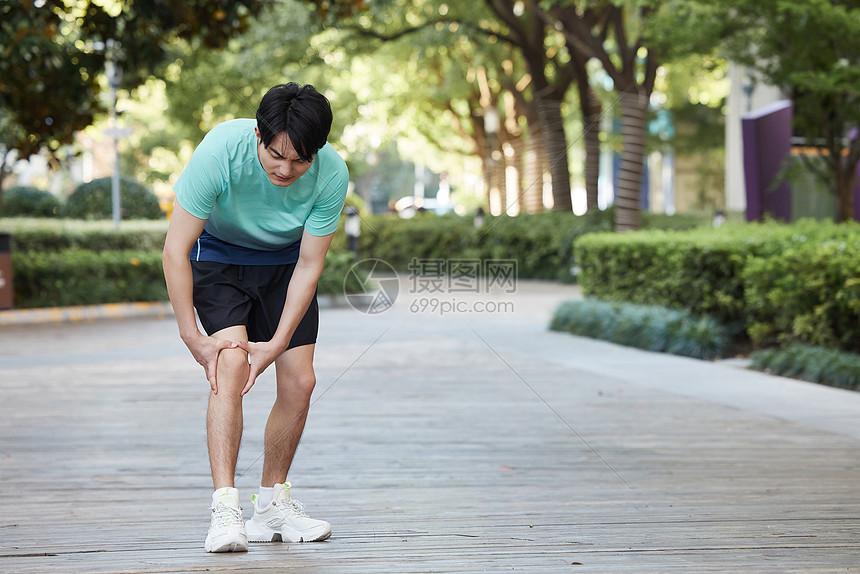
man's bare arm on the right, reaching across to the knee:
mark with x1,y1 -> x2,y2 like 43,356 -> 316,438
244,231 -> 334,395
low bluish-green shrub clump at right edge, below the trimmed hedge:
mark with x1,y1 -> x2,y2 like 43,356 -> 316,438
750,344 -> 860,391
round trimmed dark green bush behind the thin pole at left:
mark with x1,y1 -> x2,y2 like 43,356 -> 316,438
66,177 -> 164,219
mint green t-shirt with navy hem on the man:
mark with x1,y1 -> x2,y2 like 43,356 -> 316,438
174,119 -> 349,258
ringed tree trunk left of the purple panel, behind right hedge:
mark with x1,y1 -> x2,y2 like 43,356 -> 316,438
615,92 -> 648,231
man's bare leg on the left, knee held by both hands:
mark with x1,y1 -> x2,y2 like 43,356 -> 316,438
206,325 -> 248,490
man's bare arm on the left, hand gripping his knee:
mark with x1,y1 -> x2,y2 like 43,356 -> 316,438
162,202 -> 237,394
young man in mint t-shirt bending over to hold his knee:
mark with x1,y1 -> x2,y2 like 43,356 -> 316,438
164,83 -> 349,552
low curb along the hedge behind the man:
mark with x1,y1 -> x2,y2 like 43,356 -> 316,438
0,295 -> 348,327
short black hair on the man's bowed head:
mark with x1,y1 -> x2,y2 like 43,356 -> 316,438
257,82 -> 332,162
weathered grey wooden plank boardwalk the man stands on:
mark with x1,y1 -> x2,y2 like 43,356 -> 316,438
0,284 -> 860,573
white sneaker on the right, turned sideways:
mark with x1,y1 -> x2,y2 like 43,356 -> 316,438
245,482 -> 331,542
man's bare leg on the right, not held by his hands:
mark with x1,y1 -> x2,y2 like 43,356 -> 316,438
264,345 -> 316,487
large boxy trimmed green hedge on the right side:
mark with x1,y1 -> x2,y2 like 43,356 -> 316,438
575,220 -> 860,349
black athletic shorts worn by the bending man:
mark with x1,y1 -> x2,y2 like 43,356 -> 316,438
191,261 -> 319,349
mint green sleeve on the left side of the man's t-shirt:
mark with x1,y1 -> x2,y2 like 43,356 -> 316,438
173,138 -> 227,219
